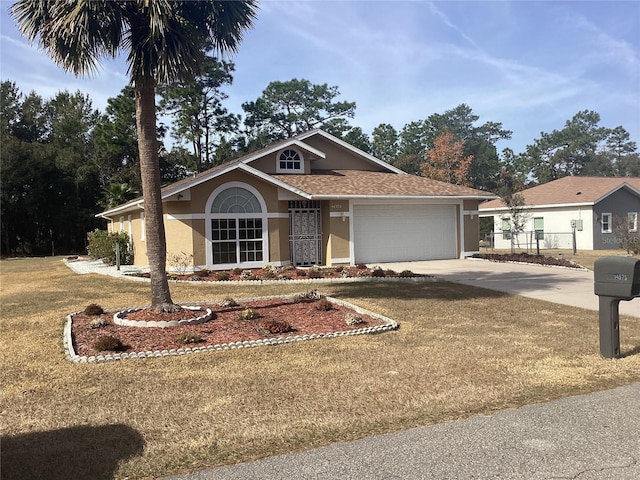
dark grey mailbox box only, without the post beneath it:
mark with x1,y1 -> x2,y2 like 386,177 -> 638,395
594,257 -> 640,300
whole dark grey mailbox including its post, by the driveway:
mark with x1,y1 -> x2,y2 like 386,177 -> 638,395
594,257 -> 640,358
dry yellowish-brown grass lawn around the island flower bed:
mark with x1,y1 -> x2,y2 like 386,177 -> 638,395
0,258 -> 640,480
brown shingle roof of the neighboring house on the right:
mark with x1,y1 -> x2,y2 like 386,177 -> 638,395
480,177 -> 640,210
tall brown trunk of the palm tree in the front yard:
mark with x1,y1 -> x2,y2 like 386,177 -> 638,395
135,77 -> 175,311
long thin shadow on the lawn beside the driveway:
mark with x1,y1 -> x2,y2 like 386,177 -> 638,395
332,282 -> 509,301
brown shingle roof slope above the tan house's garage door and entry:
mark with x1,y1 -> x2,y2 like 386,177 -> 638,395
272,170 -> 494,198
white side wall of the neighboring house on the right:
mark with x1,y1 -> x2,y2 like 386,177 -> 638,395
480,205 -> 593,250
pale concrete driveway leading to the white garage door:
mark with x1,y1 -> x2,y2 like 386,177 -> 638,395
380,259 -> 640,317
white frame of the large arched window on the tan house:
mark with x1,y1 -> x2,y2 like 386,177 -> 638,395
204,182 -> 269,270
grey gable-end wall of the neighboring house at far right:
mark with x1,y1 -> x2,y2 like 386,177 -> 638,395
592,188 -> 640,250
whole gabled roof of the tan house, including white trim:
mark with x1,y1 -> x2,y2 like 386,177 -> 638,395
97,129 -> 496,217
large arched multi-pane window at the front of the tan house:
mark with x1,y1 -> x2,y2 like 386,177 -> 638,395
209,186 -> 266,266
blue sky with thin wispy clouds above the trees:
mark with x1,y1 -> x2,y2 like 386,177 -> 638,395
0,1 -> 640,152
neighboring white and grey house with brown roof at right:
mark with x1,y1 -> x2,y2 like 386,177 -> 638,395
480,177 -> 640,250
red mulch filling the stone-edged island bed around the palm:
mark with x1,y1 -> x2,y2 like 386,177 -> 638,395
71,299 -> 382,356
